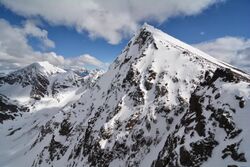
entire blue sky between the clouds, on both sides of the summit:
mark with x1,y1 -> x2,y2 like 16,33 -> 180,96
0,0 -> 250,71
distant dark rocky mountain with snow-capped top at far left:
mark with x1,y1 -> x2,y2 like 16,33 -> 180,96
0,62 -> 65,99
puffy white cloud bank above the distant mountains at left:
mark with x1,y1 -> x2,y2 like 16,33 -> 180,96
0,19 -> 105,70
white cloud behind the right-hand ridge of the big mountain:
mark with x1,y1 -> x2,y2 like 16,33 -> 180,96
194,36 -> 250,72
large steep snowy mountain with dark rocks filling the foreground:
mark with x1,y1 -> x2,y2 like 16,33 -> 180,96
0,24 -> 250,167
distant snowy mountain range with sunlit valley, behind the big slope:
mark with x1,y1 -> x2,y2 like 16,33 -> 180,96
0,62 -> 101,122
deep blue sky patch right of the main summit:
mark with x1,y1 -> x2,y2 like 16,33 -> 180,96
159,0 -> 250,43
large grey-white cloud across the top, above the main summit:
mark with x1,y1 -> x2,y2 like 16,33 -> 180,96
0,0 -> 225,44
